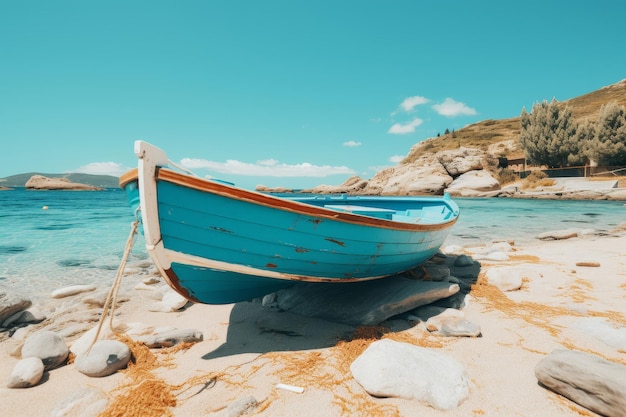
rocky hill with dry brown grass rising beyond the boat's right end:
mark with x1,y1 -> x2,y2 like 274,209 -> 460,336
288,79 -> 626,200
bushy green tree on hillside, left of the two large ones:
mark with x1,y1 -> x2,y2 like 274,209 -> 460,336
520,99 -> 584,168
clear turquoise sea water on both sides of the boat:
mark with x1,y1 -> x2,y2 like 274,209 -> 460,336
0,189 -> 626,299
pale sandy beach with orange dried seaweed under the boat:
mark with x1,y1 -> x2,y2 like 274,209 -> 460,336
0,230 -> 626,417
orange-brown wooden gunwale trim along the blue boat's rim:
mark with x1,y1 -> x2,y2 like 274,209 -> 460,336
120,167 -> 458,232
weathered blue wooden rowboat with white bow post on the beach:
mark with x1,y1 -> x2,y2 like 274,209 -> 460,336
120,141 -> 459,304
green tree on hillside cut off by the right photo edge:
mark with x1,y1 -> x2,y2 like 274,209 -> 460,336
586,102 -> 626,166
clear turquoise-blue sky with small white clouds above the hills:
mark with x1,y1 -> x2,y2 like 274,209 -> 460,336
0,0 -> 626,188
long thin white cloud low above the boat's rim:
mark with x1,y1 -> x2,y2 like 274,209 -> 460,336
180,158 -> 355,178
